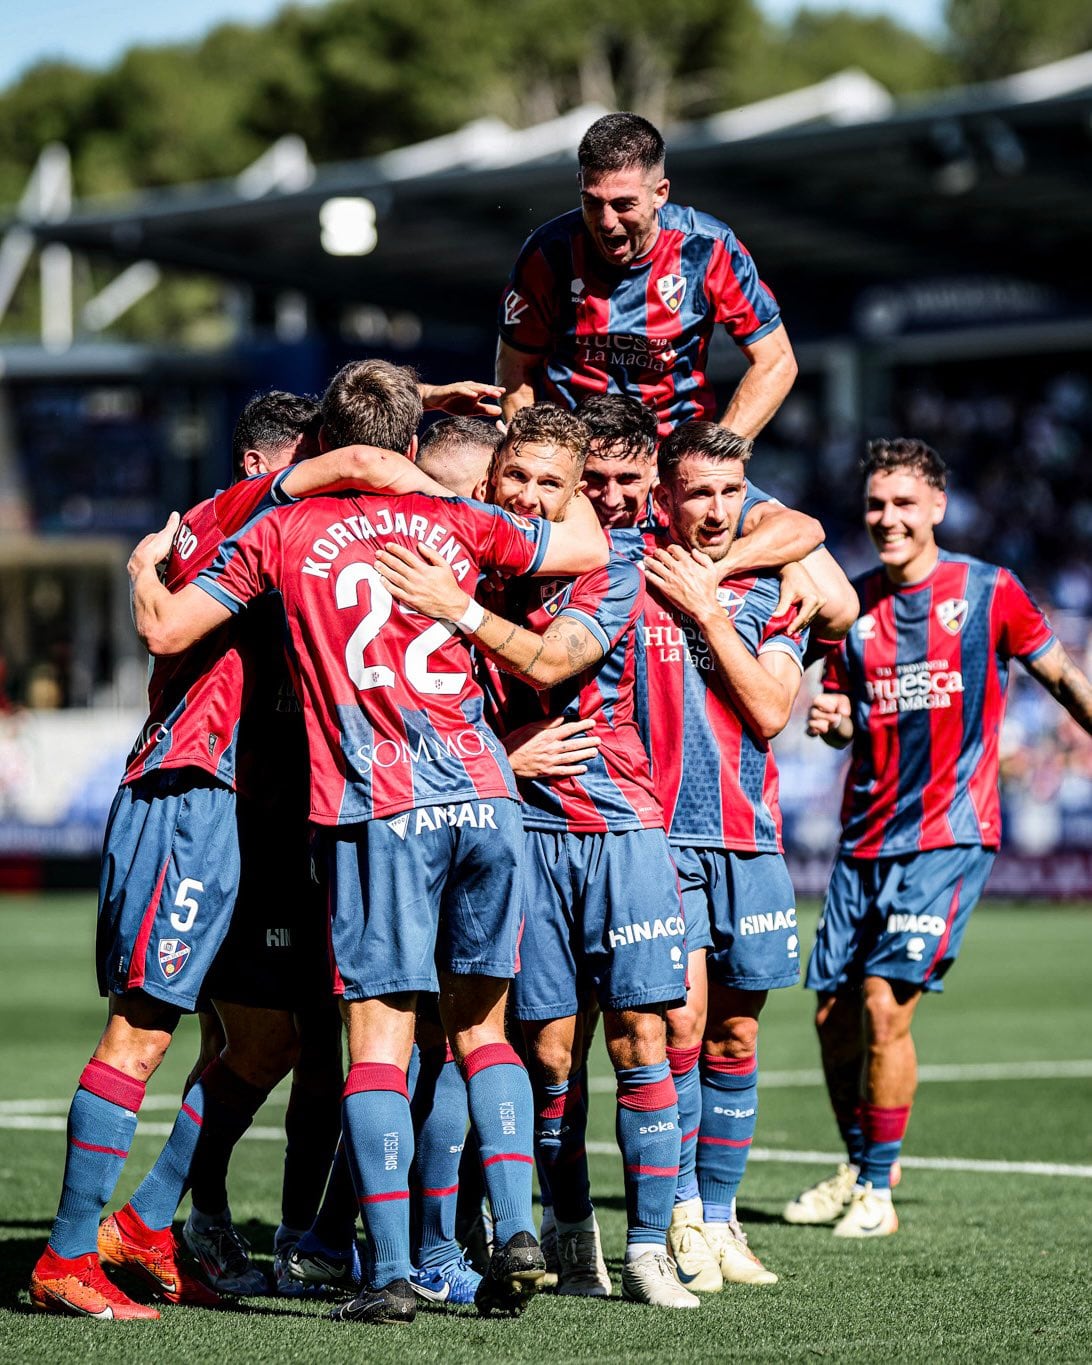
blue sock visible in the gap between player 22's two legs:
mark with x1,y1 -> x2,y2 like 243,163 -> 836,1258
411,1047 -> 467,1268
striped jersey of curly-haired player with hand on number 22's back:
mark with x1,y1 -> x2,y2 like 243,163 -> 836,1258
482,554 -> 663,834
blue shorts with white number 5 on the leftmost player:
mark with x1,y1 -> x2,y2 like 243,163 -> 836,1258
96,767 -> 239,1010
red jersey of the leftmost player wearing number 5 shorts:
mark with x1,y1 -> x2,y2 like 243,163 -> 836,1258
121,470 -> 292,788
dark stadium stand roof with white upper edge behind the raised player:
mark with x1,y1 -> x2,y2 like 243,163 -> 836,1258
12,52 -> 1092,334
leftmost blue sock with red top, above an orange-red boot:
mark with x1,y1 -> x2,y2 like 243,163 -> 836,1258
49,1059 -> 145,1259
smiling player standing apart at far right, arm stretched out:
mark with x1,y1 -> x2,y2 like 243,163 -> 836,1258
785,438 -> 1092,1238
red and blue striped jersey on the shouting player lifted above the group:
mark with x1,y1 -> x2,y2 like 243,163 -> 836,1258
498,203 -> 781,435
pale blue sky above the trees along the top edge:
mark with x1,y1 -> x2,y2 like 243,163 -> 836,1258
0,0 -> 943,87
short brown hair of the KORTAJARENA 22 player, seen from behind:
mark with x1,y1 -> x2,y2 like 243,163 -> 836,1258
322,360 -> 422,455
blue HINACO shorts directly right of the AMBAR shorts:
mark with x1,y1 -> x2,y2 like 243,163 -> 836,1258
512,830 -> 687,1020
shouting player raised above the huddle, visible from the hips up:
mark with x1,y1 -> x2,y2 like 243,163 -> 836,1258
497,113 -> 796,438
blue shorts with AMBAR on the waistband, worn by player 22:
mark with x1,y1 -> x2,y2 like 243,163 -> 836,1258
322,797 -> 523,1001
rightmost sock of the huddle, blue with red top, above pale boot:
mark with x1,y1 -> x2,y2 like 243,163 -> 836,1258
698,1057 -> 759,1223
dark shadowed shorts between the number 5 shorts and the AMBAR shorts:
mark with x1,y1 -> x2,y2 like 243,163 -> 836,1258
203,797 -> 333,1010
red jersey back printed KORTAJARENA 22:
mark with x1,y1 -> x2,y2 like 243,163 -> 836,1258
197,494 -> 550,824
